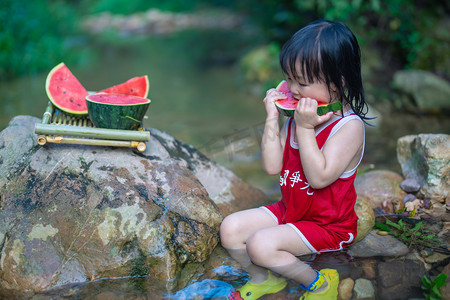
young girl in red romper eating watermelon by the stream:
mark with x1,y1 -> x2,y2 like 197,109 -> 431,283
220,20 -> 368,299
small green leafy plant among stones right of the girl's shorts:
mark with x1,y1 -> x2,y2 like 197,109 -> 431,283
375,219 -> 440,248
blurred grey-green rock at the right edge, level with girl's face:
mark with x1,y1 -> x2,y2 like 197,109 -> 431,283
394,70 -> 450,112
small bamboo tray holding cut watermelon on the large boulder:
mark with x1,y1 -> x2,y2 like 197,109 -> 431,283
34,102 -> 150,152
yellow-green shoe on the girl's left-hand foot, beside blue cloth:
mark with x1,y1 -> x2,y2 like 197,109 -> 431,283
228,271 -> 287,300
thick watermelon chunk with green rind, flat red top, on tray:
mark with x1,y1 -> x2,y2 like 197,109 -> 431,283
86,93 -> 151,130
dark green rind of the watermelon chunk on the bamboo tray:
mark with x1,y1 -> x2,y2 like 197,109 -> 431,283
86,94 -> 151,130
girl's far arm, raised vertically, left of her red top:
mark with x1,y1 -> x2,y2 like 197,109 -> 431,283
261,89 -> 286,175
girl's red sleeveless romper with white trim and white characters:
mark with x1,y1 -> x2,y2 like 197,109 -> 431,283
263,112 -> 362,253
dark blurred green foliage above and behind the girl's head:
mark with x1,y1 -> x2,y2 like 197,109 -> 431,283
236,0 -> 450,76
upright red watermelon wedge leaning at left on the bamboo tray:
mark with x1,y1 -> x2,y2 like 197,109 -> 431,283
45,63 -> 88,116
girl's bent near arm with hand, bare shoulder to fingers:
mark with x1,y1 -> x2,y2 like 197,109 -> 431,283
295,98 -> 364,189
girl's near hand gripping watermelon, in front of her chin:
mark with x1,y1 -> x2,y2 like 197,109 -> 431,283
294,98 -> 333,129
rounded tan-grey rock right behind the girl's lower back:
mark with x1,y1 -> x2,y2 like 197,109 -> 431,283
355,170 -> 406,211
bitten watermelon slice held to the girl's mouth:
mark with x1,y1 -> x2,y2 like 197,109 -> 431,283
275,80 -> 342,117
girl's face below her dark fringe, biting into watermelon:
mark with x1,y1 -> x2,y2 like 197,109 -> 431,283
286,75 -> 332,104
